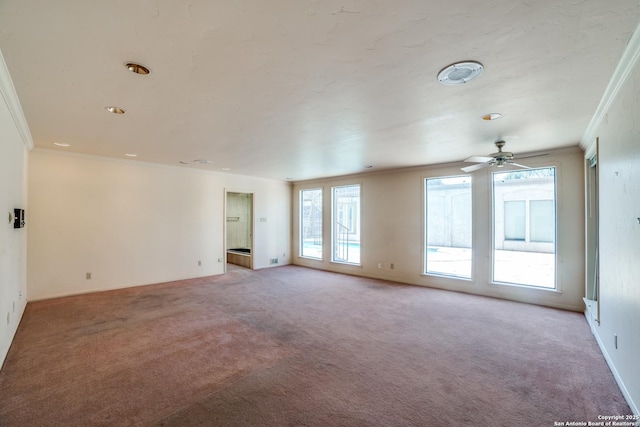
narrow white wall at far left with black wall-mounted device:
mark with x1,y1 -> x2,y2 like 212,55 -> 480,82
0,54 -> 31,366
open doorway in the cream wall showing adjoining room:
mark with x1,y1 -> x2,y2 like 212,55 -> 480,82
225,191 -> 253,269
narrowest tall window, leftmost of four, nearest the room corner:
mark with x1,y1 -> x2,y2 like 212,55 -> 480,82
300,188 -> 322,259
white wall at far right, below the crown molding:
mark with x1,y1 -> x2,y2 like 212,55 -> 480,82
588,26 -> 640,414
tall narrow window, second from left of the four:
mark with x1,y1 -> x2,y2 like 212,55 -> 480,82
332,184 -> 360,264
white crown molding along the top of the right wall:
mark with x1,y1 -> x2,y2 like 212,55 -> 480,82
580,24 -> 640,156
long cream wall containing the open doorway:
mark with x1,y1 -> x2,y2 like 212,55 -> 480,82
27,149 -> 291,300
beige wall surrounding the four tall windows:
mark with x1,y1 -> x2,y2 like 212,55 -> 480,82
292,147 -> 584,311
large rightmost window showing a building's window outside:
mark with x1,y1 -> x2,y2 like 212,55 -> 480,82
493,167 -> 556,289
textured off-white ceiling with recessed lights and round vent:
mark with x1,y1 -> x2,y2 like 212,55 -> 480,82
0,0 -> 640,180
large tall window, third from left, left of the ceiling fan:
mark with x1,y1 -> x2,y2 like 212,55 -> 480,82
425,175 -> 472,279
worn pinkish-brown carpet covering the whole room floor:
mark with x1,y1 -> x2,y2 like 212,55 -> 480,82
0,266 -> 630,426
